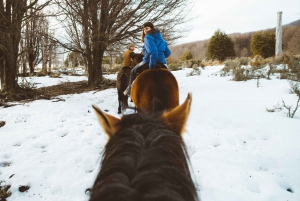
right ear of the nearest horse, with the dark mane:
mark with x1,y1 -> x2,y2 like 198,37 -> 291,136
162,93 -> 192,134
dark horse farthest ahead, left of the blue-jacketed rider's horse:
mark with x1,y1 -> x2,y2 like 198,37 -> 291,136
116,52 -> 143,114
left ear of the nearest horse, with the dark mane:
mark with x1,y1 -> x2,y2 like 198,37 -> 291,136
92,105 -> 121,137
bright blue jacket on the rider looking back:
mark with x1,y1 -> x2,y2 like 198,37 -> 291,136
143,29 -> 171,69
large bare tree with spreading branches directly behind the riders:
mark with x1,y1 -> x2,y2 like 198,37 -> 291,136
56,0 -> 190,87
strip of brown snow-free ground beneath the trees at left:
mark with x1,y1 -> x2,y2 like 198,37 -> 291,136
0,79 -> 116,103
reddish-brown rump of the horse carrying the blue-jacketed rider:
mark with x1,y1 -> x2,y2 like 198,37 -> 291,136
131,68 -> 179,113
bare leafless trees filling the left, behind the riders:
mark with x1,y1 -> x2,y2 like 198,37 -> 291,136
0,0 -> 191,98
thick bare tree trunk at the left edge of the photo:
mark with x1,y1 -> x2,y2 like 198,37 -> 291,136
0,0 -> 50,94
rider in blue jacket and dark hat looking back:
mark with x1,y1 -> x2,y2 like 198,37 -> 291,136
124,22 -> 171,96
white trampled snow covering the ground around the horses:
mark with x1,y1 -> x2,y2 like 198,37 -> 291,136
0,66 -> 300,201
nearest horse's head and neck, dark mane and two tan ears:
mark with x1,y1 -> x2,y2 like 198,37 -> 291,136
90,94 -> 198,201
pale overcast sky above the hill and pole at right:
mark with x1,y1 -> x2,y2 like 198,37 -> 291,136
177,0 -> 300,44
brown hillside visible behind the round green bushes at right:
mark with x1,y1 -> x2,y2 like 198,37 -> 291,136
170,19 -> 300,60
